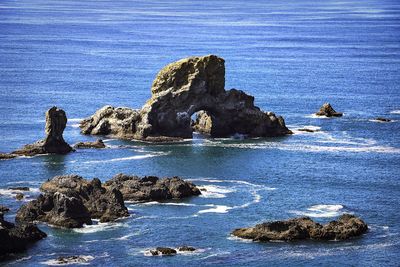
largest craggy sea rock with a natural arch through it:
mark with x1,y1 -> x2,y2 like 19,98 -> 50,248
80,55 -> 291,141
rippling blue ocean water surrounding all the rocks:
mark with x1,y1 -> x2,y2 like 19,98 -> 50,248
0,0 -> 400,266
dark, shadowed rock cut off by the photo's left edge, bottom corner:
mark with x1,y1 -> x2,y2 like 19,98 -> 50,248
0,206 -> 46,260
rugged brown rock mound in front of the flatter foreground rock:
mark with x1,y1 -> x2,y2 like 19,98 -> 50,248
16,175 -> 129,228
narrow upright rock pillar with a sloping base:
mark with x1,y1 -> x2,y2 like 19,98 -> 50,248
11,107 -> 73,156
